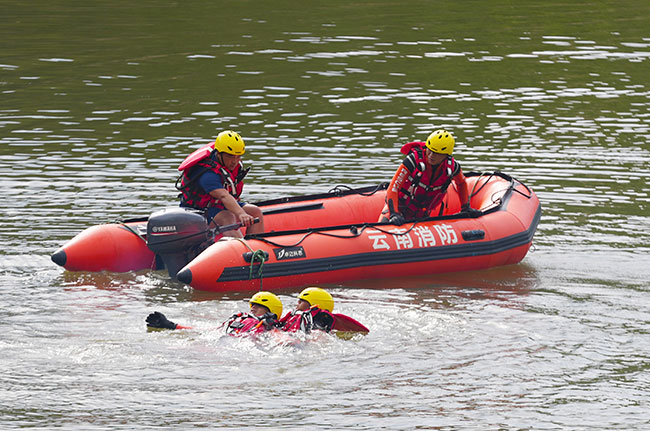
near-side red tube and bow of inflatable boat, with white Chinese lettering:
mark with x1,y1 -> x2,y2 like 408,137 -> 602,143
177,173 -> 541,292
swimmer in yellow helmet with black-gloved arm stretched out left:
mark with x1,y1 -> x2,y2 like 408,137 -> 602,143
146,292 -> 282,336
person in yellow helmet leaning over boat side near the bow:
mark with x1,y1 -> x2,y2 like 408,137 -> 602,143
379,130 -> 480,226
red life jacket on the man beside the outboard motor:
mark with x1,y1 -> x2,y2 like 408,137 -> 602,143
176,152 -> 248,209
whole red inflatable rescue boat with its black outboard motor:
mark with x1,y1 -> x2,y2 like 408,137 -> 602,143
52,172 -> 541,292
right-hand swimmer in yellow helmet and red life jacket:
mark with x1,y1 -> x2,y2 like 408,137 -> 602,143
279,287 -> 335,333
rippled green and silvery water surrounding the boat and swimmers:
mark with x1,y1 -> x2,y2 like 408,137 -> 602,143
0,1 -> 650,430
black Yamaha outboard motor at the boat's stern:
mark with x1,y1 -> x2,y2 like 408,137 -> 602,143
147,207 -> 214,278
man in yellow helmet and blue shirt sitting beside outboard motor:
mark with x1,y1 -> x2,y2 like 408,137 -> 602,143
176,130 -> 264,237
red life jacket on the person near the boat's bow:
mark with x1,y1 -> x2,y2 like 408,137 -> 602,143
398,142 -> 460,220
